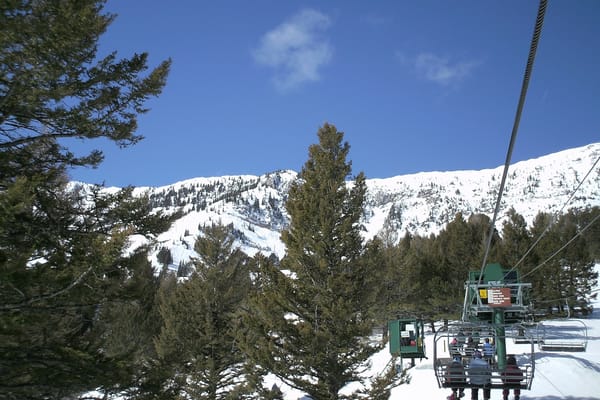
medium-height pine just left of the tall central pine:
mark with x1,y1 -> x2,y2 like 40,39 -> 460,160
156,225 -> 250,400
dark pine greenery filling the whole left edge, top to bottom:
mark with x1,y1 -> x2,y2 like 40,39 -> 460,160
0,0 -> 171,399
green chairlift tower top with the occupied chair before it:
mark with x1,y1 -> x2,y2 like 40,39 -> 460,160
433,264 -> 535,389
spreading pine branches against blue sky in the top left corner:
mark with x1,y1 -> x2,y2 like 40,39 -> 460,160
0,0 -> 170,170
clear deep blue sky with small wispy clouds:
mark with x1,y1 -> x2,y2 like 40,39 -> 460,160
71,0 -> 600,186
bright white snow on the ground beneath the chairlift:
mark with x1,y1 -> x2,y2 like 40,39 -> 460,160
276,264 -> 600,400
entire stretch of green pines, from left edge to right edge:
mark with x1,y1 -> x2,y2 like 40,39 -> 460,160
0,0 -> 600,400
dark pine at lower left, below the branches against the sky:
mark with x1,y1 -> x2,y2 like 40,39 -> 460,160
0,178 -> 177,398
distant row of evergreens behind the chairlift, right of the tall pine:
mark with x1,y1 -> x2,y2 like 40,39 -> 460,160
382,207 -> 600,320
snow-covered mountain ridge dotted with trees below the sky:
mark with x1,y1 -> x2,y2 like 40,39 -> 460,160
129,143 -> 600,266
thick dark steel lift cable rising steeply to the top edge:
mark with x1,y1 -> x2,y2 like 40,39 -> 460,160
479,0 -> 547,282
